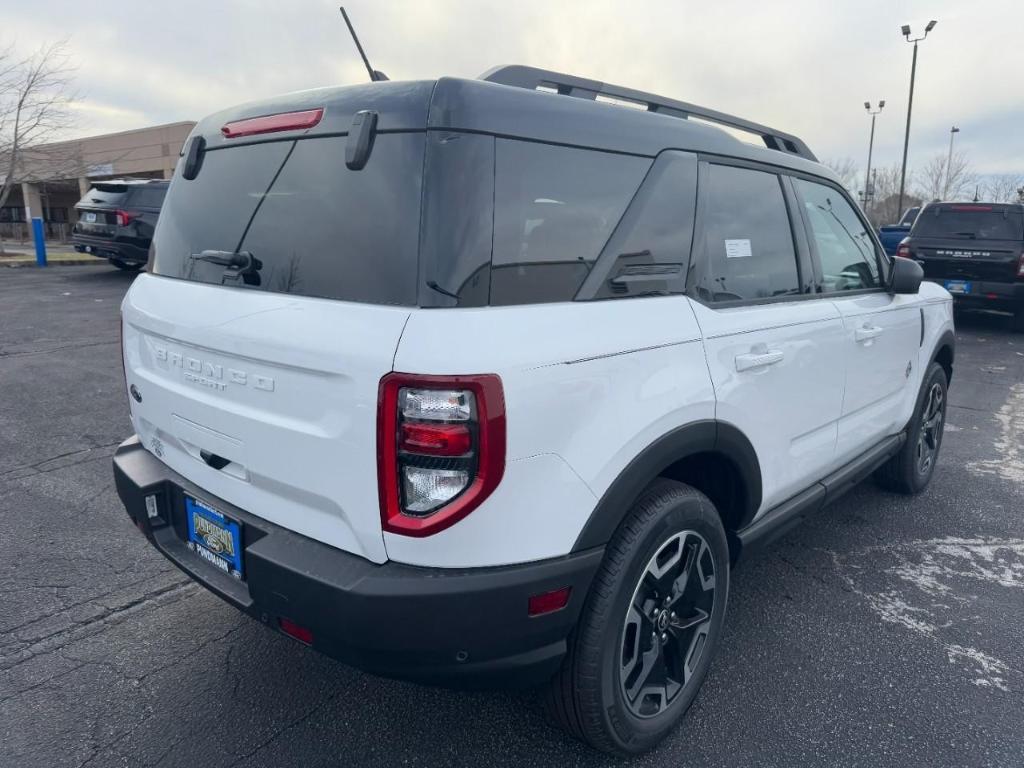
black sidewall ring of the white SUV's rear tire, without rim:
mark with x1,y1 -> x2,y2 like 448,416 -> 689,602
599,484 -> 729,753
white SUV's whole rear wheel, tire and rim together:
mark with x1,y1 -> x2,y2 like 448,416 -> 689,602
545,479 -> 729,755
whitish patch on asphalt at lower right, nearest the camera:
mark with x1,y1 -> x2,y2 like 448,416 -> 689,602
831,537 -> 1024,691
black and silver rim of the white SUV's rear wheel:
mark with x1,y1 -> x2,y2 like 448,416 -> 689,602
618,530 -> 716,718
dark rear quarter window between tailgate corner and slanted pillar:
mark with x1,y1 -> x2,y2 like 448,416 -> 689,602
490,139 -> 651,305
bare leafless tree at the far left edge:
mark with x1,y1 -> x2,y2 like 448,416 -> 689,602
0,40 -> 74,253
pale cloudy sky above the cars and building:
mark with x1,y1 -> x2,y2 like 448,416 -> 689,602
8,0 -> 1024,173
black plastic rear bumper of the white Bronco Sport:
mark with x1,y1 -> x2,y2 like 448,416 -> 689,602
114,437 -> 603,687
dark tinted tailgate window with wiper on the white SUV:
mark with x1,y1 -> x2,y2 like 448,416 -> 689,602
154,133 -> 424,305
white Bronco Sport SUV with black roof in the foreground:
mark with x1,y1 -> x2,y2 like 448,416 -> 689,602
114,67 -> 953,753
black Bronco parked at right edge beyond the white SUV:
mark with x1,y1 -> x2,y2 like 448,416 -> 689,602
897,203 -> 1024,332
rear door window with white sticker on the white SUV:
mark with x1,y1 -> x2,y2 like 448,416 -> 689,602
690,165 -> 800,302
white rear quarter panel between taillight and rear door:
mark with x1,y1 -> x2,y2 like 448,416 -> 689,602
384,296 -> 715,567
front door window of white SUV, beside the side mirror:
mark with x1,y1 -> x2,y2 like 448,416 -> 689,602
794,179 -> 882,293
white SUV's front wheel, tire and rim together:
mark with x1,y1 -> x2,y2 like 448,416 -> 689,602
874,362 -> 947,494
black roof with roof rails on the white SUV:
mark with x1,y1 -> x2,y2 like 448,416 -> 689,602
193,68 -> 838,181
